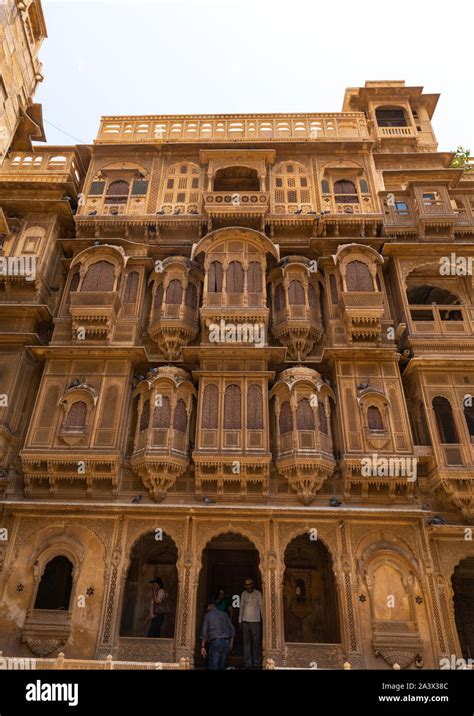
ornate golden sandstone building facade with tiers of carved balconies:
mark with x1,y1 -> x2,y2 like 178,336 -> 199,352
0,2 -> 474,670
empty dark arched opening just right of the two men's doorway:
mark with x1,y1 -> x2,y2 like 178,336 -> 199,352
283,534 -> 341,644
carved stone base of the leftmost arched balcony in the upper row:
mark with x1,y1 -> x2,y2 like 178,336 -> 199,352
69,291 -> 121,340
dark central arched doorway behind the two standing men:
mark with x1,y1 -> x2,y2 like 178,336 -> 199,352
195,532 -> 262,669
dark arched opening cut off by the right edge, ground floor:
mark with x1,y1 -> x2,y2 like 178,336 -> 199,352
452,557 -> 474,659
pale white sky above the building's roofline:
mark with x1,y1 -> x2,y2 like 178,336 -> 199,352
36,0 -> 474,153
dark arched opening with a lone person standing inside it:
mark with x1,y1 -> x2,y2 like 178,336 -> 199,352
120,532 -> 178,639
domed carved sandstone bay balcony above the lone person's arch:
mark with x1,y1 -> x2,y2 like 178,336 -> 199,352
131,366 -> 196,502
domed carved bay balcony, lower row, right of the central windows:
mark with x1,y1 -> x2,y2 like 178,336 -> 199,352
271,367 -> 336,505
